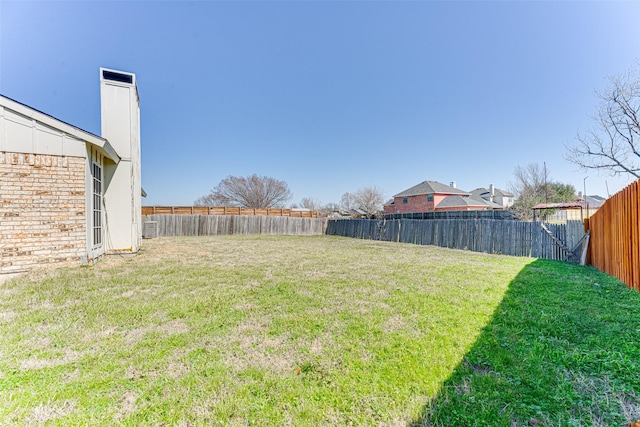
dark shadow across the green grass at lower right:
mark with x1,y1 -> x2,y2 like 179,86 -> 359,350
410,260 -> 640,427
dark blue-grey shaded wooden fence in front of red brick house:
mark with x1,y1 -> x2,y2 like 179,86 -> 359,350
326,219 -> 584,260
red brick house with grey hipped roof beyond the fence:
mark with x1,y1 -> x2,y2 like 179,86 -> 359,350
384,181 -> 501,214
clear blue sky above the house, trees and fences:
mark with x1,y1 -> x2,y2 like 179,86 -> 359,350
0,0 -> 640,205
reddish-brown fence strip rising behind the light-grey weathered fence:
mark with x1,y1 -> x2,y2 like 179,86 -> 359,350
142,206 -> 318,218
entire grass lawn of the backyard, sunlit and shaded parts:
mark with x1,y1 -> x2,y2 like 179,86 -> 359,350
0,236 -> 640,426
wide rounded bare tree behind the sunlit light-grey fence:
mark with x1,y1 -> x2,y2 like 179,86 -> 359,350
194,174 -> 291,209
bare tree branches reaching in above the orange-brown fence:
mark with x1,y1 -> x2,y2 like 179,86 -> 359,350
566,67 -> 640,178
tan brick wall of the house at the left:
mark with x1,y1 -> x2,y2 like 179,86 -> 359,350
0,152 -> 86,273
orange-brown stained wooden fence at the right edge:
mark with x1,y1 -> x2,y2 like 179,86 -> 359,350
586,180 -> 640,291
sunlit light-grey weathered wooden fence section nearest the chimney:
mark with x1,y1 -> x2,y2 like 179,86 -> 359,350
142,214 -> 326,237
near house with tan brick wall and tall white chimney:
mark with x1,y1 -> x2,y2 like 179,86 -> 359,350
0,69 -> 142,273
